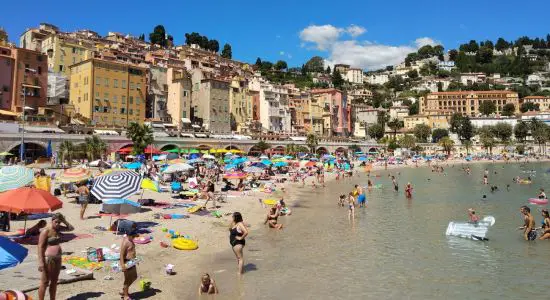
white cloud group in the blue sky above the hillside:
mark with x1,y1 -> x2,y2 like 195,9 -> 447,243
300,25 -> 440,70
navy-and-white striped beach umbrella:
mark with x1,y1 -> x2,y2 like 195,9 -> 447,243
92,171 -> 141,200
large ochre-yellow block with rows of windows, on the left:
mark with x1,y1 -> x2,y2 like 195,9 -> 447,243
70,59 -> 146,127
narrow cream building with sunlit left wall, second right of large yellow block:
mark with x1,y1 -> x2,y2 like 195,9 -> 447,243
166,68 -> 192,131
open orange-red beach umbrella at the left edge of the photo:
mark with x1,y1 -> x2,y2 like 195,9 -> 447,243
0,187 -> 63,213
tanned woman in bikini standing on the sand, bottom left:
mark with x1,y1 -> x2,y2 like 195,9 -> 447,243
38,213 -> 74,300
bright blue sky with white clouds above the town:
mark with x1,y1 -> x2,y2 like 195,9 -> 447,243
0,0 -> 550,70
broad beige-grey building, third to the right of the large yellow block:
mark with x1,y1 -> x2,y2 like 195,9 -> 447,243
198,78 -> 231,134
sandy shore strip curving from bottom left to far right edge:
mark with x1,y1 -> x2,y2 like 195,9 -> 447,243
12,159 -> 550,299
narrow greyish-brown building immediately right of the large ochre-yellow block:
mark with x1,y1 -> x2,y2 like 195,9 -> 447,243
145,65 -> 170,124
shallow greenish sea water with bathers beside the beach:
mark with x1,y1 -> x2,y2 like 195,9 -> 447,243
191,164 -> 550,299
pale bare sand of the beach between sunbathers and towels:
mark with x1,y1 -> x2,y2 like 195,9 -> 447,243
2,159 -> 540,299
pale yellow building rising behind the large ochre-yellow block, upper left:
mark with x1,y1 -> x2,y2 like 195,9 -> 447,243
41,33 -> 94,77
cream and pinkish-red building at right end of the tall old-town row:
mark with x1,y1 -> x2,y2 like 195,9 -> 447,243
311,89 -> 352,136
